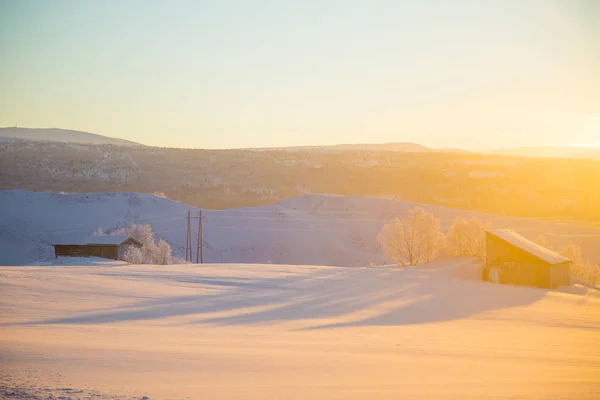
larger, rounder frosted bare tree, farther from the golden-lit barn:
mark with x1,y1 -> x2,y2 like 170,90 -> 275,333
377,207 -> 443,267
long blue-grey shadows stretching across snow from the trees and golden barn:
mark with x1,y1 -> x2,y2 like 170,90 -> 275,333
9,262 -> 546,329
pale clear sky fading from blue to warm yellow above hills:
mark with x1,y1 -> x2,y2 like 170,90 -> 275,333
0,0 -> 600,149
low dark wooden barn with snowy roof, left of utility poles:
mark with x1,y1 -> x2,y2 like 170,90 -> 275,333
53,235 -> 142,260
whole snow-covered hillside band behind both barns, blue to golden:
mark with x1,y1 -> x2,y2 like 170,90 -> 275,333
0,191 -> 600,266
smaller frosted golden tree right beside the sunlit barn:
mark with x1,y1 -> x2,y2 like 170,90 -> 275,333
447,217 -> 491,257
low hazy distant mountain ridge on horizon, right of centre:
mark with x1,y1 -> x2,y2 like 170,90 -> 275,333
252,142 -> 469,153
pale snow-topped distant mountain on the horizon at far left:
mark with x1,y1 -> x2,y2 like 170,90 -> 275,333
0,127 -> 141,146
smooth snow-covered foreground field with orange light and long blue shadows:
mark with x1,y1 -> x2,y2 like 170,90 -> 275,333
0,260 -> 600,400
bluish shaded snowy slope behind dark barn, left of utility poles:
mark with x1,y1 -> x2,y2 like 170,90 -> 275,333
0,191 -> 192,265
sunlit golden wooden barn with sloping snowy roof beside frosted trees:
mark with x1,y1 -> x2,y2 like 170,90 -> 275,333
483,229 -> 571,289
